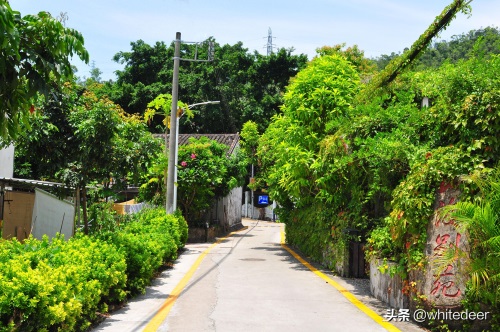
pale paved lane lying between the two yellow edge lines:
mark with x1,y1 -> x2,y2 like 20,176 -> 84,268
154,221 -> 392,332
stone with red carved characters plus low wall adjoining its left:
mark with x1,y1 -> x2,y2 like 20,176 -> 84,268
370,182 -> 467,322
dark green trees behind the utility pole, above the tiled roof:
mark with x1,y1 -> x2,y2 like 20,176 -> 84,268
106,38 -> 307,133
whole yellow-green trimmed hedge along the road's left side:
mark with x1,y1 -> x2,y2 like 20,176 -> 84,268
0,209 -> 187,331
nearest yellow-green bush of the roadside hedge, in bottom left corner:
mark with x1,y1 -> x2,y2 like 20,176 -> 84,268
0,236 -> 126,331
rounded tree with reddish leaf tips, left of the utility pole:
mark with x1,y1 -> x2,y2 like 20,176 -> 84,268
15,83 -> 161,230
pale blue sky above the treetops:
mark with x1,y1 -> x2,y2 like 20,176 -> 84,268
9,0 -> 500,80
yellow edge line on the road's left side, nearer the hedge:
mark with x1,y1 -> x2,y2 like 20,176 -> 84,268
143,228 -> 241,332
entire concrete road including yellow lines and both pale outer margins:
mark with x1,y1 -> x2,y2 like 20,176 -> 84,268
93,220 -> 422,332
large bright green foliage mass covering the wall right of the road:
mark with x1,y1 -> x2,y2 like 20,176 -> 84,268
258,43 -> 500,330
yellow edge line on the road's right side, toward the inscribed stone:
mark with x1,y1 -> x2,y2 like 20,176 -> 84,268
280,227 -> 401,332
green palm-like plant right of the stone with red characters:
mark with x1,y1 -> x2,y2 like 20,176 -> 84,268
434,167 -> 500,306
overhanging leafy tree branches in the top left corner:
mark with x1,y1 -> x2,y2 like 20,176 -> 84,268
0,0 -> 89,140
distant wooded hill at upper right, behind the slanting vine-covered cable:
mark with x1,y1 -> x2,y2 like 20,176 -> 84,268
372,27 -> 500,70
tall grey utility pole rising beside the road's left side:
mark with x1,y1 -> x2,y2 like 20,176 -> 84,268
165,32 -> 181,214
